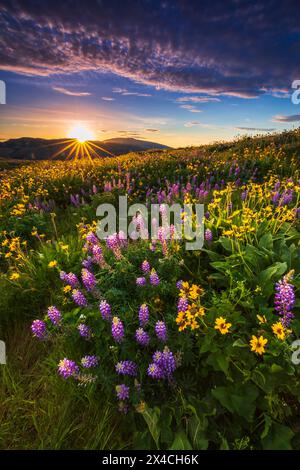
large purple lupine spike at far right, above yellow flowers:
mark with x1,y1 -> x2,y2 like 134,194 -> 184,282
274,271 -> 296,326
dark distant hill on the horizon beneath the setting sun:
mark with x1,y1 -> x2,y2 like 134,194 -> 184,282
0,137 -> 170,160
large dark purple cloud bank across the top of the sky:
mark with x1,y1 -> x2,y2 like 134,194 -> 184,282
0,0 -> 300,98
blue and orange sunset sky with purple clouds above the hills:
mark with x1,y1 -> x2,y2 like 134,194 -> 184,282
0,0 -> 300,147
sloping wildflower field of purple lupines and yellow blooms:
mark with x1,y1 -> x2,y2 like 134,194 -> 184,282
0,130 -> 300,450
